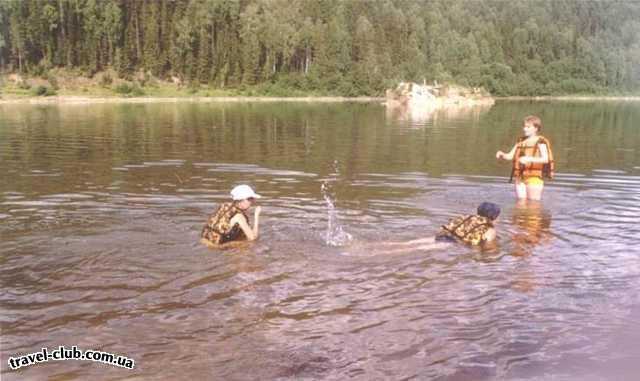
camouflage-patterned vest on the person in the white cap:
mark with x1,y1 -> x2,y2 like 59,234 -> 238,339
200,202 -> 249,244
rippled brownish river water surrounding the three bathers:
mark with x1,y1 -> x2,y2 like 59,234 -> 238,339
0,101 -> 640,380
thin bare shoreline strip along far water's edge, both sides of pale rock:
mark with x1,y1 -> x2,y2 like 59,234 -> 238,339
0,95 -> 640,105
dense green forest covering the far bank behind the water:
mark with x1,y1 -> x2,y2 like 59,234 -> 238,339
0,0 -> 640,96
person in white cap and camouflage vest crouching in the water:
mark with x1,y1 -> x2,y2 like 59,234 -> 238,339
200,184 -> 262,246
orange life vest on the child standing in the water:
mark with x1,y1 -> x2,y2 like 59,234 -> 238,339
509,136 -> 556,182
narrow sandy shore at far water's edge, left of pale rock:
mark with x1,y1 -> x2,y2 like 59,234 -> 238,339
0,95 -> 384,104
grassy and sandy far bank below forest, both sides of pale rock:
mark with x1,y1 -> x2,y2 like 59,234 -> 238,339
0,69 -> 640,103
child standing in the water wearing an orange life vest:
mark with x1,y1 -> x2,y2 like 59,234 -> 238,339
496,115 -> 555,200
